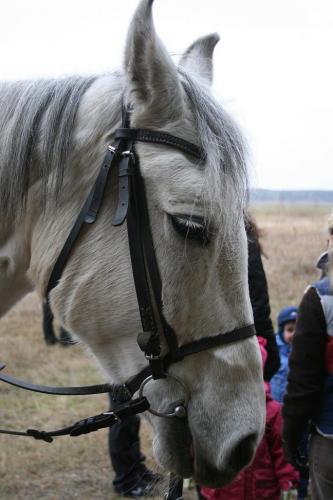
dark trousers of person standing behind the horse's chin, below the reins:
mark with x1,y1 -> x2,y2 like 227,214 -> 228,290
109,396 -> 146,493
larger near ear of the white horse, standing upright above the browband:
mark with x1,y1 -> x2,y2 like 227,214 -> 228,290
125,0 -> 182,121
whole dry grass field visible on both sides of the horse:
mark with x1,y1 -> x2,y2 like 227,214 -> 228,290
0,205 -> 332,500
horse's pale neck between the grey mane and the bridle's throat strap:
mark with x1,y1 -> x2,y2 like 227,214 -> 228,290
0,76 -> 122,316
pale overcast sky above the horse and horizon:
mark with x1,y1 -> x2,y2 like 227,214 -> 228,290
0,0 -> 333,190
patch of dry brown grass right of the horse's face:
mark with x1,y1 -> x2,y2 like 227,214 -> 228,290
252,204 -> 332,321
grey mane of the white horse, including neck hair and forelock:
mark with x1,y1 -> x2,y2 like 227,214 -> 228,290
0,69 -> 247,229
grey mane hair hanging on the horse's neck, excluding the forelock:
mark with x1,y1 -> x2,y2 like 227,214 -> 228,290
0,77 -> 95,217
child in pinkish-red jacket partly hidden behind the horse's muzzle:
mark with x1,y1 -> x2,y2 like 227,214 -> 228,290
201,337 -> 299,500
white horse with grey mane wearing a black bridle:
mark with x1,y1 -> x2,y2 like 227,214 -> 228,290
0,0 -> 265,486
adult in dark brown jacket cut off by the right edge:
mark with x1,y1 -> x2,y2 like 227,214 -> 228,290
282,216 -> 333,500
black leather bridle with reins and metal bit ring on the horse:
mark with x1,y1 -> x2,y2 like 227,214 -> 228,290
0,104 -> 255,496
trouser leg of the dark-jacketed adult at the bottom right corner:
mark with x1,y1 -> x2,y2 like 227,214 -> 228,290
309,434 -> 333,500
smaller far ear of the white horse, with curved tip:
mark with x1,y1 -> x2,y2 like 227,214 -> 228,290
179,33 -> 220,85
